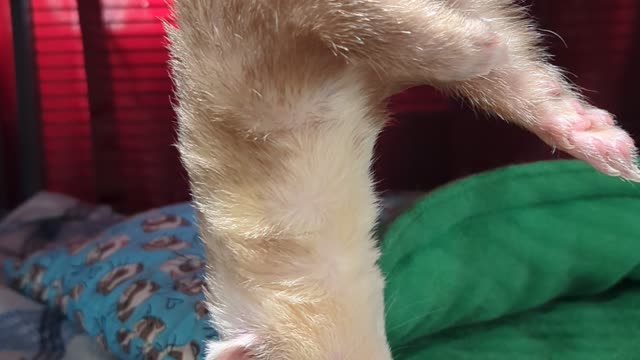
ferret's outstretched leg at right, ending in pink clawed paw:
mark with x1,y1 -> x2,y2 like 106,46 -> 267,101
437,0 -> 640,181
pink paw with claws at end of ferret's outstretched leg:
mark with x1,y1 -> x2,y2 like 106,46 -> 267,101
537,99 -> 640,182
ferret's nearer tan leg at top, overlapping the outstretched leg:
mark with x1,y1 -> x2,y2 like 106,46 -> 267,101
306,0 -> 507,85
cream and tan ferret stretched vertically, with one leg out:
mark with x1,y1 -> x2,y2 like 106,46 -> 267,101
167,0 -> 640,360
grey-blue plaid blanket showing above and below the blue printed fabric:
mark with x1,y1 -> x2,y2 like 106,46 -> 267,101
0,193 -> 121,360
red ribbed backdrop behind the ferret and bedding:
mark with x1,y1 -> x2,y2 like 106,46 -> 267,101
0,0 -> 640,211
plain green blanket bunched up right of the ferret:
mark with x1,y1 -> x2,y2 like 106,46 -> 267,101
380,161 -> 640,360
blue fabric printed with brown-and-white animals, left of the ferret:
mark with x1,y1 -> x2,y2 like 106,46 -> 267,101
4,204 -> 216,359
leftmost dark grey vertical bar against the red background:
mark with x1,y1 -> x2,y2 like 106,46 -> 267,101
11,0 -> 44,201
